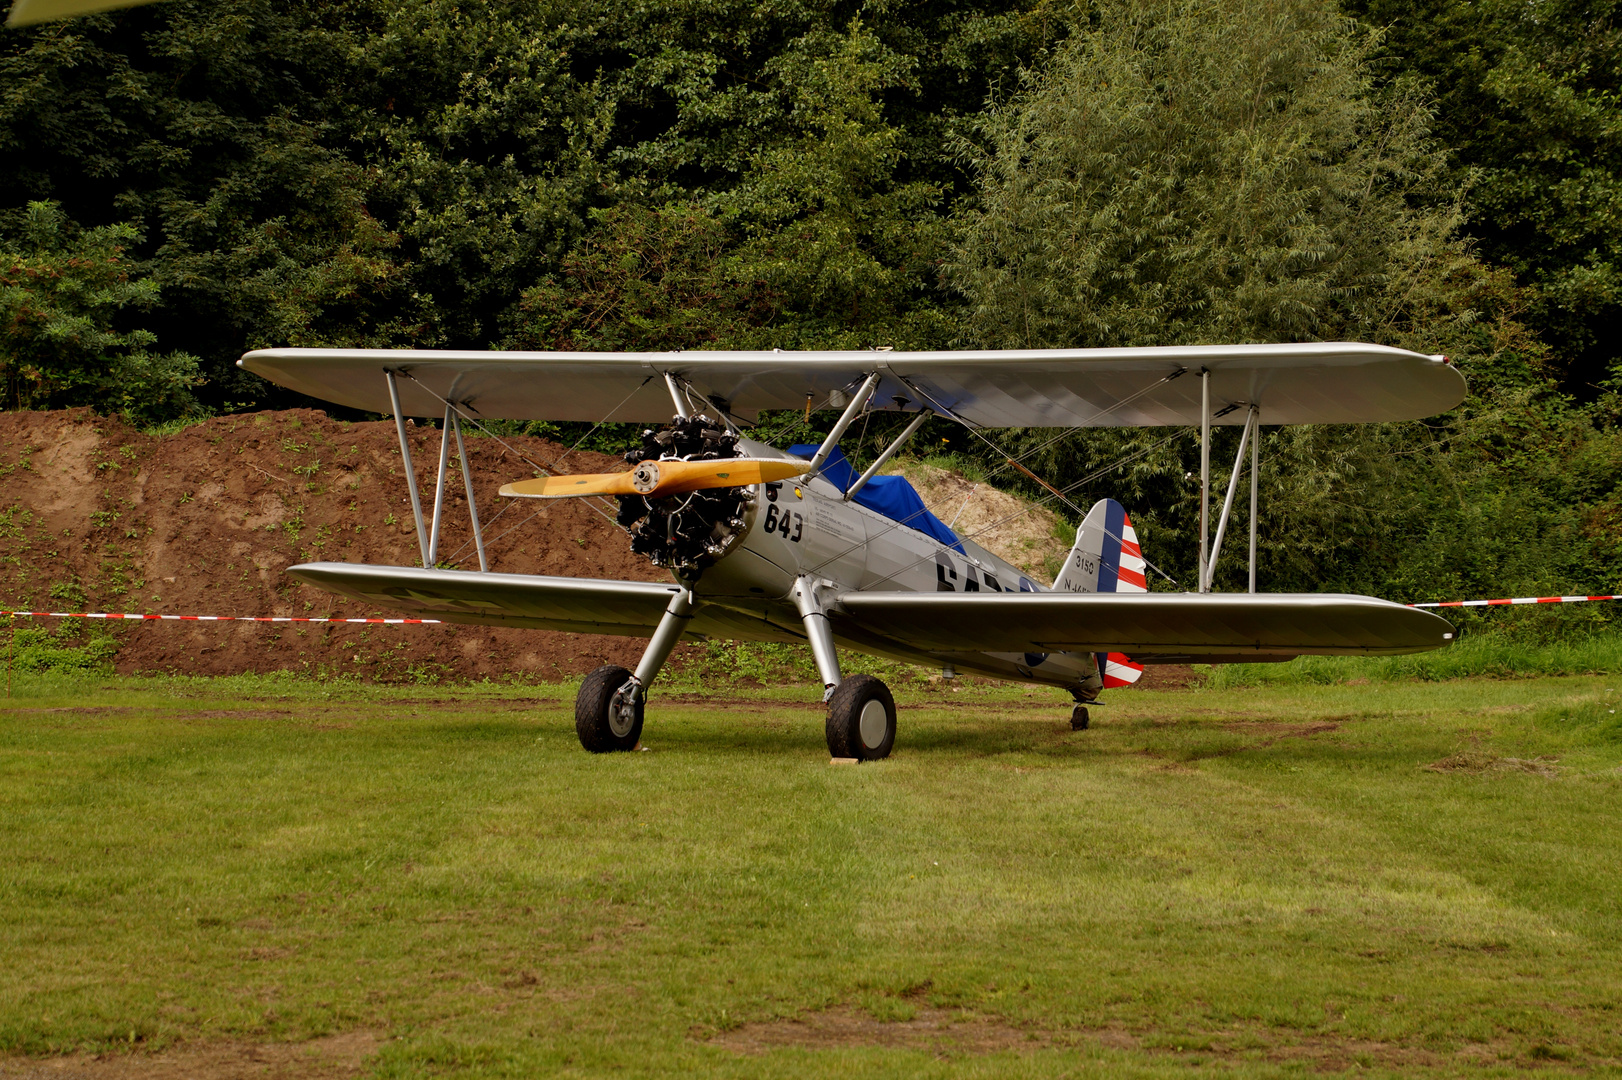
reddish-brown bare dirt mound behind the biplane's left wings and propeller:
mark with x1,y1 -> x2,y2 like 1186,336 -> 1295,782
0,409 -> 688,679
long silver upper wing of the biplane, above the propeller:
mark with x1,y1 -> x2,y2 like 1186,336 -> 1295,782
238,342 -> 1465,428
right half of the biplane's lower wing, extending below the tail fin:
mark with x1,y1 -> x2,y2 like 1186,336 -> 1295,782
835,592 -> 1453,662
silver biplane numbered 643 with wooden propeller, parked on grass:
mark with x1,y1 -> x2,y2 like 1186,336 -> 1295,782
240,342 -> 1465,761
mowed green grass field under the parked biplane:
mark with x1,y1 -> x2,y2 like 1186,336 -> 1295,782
0,676 -> 1622,1077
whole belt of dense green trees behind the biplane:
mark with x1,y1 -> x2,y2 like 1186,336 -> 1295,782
0,0 -> 1622,609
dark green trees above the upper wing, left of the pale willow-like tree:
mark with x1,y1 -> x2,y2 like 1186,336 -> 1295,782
0,0 -> 1062,407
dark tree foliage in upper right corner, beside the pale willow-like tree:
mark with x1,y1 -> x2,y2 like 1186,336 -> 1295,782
1346,0 -> 1622,389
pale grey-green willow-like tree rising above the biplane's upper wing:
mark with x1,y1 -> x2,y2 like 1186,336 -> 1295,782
950,0 -> 1470,350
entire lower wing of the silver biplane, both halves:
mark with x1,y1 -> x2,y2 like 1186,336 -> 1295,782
287,563 -> 1453,663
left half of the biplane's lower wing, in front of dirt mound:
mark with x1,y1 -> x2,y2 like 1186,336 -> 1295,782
287,563 -> 800,642
